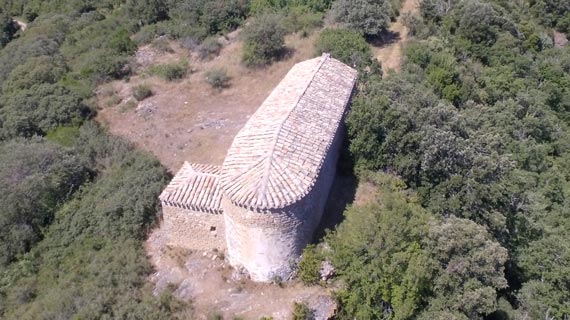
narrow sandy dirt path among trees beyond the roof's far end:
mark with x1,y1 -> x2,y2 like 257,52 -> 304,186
373,0 -> 418,75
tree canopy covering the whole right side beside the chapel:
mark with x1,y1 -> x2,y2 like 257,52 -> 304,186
313,0 -> 570,319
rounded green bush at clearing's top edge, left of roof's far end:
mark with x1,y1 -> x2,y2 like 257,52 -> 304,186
242,14 -> 286,67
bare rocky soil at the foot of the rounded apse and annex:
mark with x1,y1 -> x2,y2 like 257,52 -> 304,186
146,228 -> 336,320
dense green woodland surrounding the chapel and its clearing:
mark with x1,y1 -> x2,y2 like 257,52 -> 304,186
0,0 -> 570,319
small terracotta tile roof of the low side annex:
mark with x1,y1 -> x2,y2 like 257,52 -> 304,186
159,162 -> 222,213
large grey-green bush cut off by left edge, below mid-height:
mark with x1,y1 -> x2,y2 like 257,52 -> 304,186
0,139 -> 86,267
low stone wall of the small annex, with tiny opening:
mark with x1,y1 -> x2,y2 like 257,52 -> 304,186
160,205 -> 226,250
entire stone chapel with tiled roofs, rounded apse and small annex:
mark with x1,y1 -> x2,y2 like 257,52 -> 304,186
160,54 -> 357,281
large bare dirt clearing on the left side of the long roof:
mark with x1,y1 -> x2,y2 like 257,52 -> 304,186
97,33 -> 317,172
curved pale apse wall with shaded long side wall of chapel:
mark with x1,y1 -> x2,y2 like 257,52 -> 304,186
222,122 -> 344,281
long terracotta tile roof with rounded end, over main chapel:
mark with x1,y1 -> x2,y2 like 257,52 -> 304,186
221,54 -> 357,209
